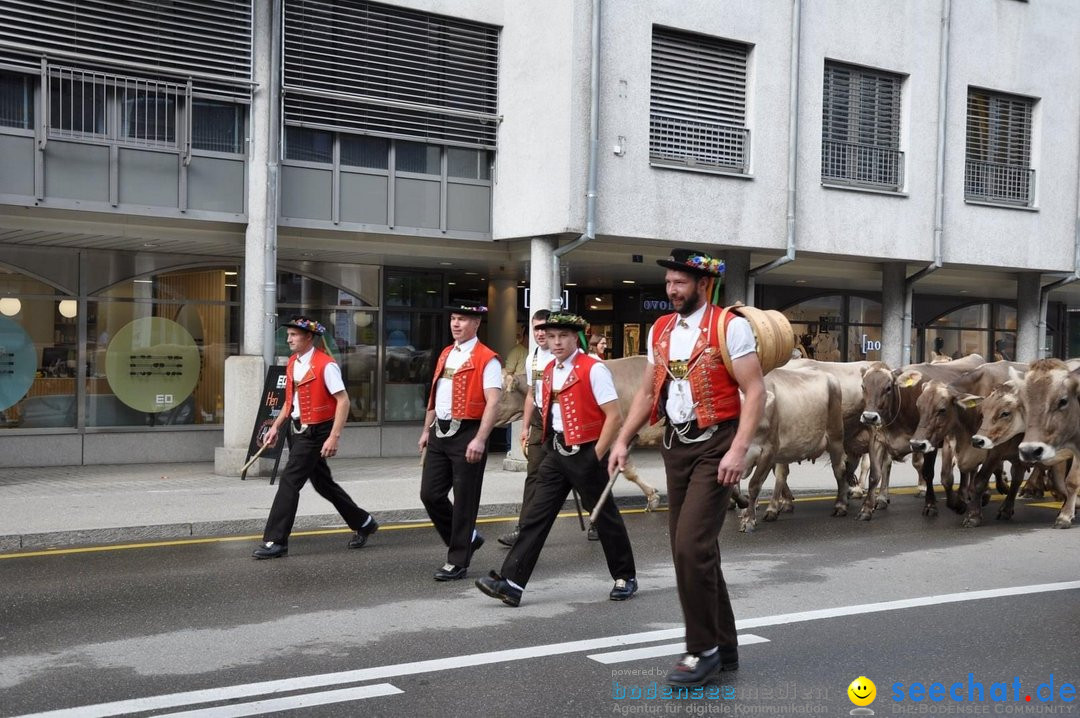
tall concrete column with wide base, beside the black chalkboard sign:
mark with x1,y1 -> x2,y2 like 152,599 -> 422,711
214,2 -> 278,476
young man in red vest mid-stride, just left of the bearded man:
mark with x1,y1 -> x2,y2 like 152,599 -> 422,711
476,313 -> 637,606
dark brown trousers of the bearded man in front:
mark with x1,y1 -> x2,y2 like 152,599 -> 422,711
662,420 -> 739,655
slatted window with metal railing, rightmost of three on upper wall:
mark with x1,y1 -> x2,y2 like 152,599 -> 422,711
963,89 -> 1035,206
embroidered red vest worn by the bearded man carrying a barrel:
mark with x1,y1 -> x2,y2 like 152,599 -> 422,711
649,306 -> 742,429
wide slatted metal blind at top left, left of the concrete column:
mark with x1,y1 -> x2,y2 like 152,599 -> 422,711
0,0 -> 251,98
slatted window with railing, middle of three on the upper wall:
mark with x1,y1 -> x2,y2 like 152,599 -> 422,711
821,62 -> 904,190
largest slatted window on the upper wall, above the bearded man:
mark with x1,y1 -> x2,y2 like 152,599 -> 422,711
649,27 -> 750,172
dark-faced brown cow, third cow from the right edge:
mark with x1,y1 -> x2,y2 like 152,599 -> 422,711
910,362 -> 1027,528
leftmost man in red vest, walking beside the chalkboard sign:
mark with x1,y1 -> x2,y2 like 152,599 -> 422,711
252,316 -> 379,558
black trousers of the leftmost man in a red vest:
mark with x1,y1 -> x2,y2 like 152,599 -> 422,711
262,420 -> 370,544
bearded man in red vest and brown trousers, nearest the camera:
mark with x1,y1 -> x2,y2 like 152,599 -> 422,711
609,249 -> 765,686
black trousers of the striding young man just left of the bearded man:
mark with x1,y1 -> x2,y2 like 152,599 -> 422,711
501,437 -> 637,588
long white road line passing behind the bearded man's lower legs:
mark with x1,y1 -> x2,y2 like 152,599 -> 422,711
16,581 -> 1080,718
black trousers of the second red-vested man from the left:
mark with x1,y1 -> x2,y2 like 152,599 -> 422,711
420,420 -> 487,566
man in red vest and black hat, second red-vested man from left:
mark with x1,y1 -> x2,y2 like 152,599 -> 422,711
418,303 -> 502,581
